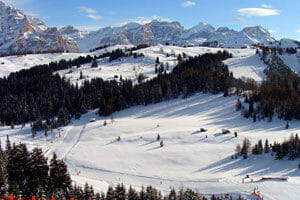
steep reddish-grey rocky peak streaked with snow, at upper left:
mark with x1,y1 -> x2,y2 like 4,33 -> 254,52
0,1 -> 79,54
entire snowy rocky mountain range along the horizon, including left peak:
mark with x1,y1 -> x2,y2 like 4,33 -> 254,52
0,1 -> 299,54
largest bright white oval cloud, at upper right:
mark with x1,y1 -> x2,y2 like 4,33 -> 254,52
237,8 -> 280,17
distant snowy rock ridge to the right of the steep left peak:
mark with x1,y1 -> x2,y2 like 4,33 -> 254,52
60,20 -> 275,51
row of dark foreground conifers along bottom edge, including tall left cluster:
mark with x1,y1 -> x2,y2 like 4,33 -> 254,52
0,137 -> 243,200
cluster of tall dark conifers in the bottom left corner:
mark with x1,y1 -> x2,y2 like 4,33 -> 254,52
0,137 -> 73,198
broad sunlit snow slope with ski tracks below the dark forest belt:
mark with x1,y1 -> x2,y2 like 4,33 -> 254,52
0,94 -> 300,200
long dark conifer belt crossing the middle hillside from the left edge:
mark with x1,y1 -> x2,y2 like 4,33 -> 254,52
0,50 -> 234,129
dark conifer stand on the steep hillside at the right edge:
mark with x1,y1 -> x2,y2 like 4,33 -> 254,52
241,47 -> 300,122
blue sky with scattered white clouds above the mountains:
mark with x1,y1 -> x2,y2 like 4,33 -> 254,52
3,0 -> 300,40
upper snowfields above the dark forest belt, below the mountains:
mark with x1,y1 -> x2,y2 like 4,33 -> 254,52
0,45 -> 266,82
